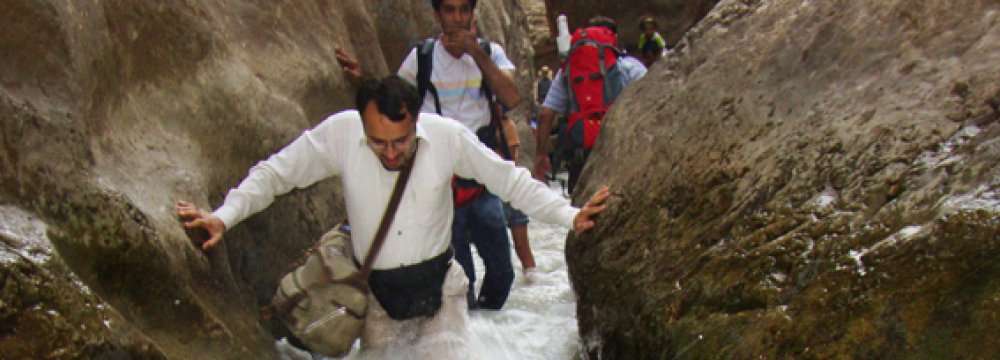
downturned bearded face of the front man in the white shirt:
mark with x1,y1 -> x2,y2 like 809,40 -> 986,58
361,101 -> 417,171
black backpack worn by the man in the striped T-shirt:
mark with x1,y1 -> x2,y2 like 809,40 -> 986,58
416,38 -> 513,160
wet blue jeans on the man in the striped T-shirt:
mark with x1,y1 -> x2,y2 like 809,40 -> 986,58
451,191 -> 514,310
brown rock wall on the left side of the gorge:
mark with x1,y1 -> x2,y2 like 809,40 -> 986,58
0,0 -> 531,359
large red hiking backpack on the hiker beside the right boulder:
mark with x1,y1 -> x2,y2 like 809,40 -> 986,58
563,26 -> 625,150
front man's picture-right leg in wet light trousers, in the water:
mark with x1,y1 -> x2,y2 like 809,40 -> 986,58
416,262 -> 469,359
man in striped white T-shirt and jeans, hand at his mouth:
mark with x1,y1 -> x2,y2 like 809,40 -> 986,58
372,0 -> 523,310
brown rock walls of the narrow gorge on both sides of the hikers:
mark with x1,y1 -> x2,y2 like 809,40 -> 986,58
0,0 -> 1000,359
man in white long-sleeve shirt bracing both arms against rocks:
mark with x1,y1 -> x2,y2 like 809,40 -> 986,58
177,76 -> 610,358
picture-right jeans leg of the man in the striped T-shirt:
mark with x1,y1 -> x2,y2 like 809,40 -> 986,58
470,192 -> 514,310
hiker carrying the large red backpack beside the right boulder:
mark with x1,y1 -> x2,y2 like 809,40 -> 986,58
533,16 -> 646,193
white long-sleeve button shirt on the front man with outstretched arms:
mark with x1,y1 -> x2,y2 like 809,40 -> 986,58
214,110 -> 579,270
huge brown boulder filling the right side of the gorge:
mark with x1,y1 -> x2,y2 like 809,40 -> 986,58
567,0 -> 1000,359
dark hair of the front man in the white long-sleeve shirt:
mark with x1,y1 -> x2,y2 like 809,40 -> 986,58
355,75 -> 420,122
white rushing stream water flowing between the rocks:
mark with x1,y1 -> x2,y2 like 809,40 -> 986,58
278,186 -> 580,360
